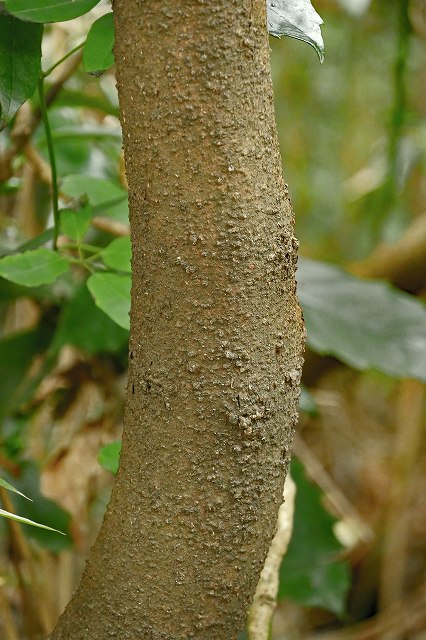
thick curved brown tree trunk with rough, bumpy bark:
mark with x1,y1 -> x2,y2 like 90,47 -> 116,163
51,0 -> 303,640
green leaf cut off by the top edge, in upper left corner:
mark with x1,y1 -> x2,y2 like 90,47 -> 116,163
5,0 -> 100,22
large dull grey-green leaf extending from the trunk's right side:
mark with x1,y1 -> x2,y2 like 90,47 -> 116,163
297,258 -> 426,382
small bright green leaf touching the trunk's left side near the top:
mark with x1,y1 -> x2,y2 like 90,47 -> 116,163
83,12 -> 114,73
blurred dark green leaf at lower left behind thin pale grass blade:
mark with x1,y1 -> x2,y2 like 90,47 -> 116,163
7,460 -> 72,553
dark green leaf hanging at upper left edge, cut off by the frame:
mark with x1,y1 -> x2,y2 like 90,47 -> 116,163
0,14 -> 43,129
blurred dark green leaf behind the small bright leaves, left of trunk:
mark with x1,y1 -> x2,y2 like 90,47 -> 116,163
52,283 -> 129,353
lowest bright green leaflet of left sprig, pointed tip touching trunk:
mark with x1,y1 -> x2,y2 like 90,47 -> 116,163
87,272 -> 131,329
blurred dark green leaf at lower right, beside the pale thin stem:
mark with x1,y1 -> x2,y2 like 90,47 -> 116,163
278,460 -> 350,616
